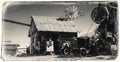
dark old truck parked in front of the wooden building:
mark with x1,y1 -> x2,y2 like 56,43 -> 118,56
61,37 -> 90,56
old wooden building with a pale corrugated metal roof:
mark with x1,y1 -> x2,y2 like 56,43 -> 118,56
29,16 -> 78,54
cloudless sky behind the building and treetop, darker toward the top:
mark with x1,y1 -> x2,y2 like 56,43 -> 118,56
3,2 -> 97,47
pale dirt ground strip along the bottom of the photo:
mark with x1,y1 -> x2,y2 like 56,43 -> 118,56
3,55 -> 116,61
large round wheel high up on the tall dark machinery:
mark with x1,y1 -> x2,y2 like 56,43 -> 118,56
91,6 -> 109,24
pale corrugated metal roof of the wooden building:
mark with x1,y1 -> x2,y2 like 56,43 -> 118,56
32,16 -> 77,32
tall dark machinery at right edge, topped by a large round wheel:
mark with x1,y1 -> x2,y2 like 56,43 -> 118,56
91,2 -> 118,54
